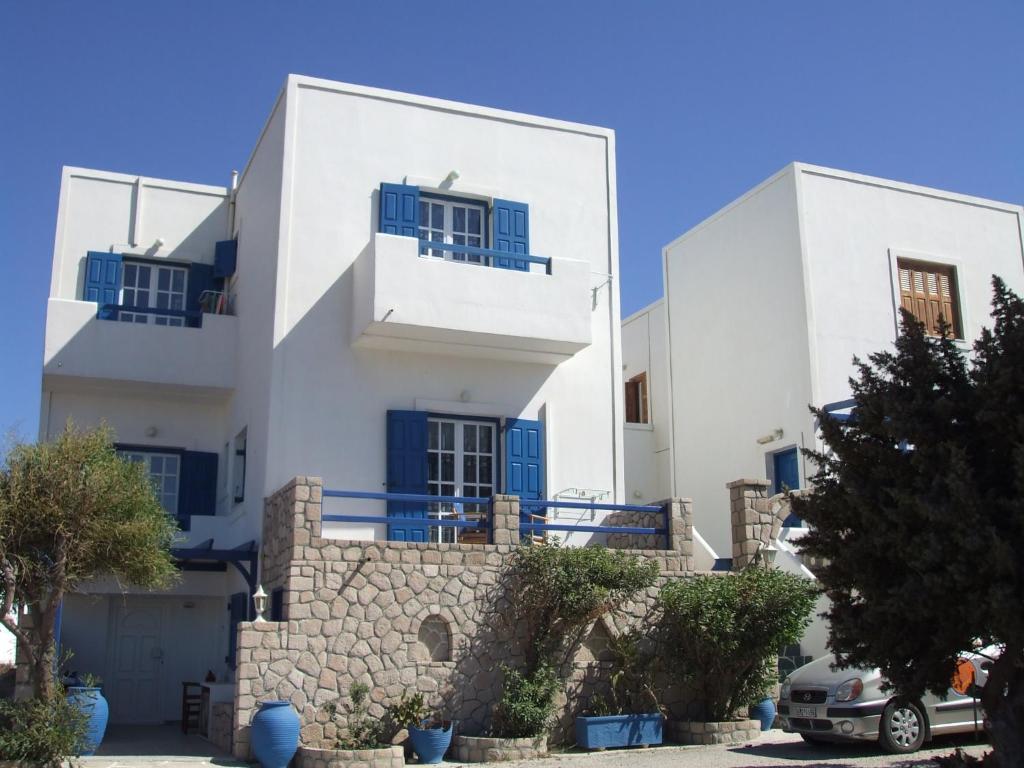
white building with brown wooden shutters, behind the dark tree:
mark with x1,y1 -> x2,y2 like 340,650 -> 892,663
623,163 -> 1024,557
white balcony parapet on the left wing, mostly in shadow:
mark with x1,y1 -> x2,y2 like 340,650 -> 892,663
43,299 -> 238,397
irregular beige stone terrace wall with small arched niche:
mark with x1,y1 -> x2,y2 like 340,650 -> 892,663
233,477 -> 693,758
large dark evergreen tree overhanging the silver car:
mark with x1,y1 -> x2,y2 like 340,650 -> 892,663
794,279 -> 1024,768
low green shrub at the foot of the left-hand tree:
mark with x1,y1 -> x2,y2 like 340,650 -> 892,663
0,686 -> 88,768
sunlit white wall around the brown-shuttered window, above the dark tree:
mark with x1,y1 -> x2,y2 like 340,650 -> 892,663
797,165 -> 1024,404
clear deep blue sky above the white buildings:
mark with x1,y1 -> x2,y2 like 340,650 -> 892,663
0,0 -> 1024,437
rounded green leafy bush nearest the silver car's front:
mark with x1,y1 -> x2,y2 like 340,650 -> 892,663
657,566 -> 817,722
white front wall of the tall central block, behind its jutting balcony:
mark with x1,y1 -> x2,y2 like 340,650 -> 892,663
260,77 -> 623,509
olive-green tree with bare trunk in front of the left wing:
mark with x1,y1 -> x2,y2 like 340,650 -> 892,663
0,422 -> 177,699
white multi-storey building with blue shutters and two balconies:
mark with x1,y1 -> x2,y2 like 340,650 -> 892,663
40,76 -> 626,723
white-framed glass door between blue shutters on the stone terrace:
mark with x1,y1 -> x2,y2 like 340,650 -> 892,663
427,417 -> 498,543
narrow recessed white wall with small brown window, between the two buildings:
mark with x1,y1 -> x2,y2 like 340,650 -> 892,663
623,300 -> 672,504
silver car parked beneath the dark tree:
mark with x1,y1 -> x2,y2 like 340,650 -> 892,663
778,648 -> 998,753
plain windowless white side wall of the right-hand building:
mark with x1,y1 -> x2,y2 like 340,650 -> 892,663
664,168 -> 813,557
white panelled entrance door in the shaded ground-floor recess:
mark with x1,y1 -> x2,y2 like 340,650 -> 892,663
106,598 -> 164,724
